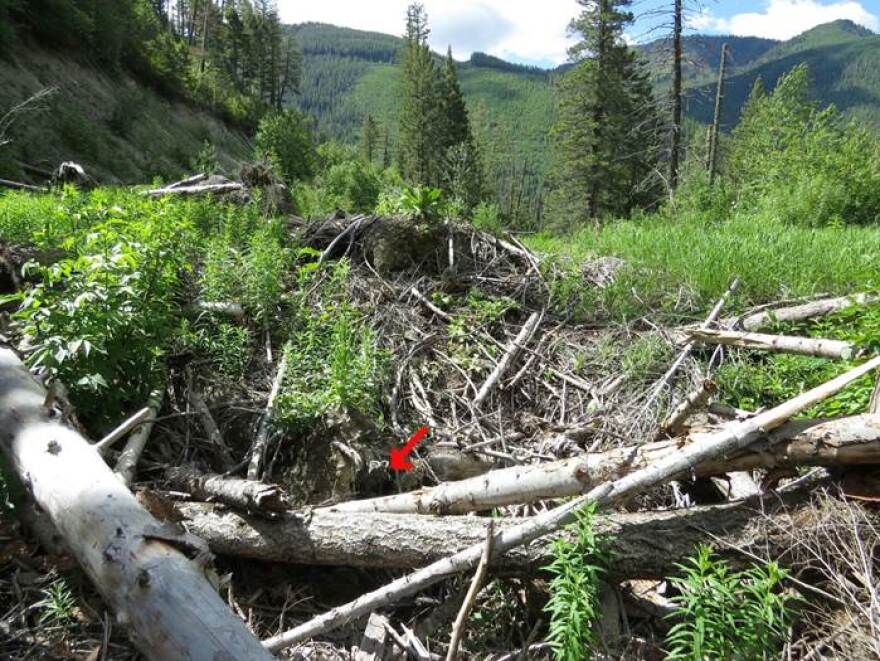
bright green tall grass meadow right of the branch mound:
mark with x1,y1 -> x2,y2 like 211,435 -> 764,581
526,214 -> 880,316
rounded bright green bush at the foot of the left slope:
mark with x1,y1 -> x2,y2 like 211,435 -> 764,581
255,109 -> 315,184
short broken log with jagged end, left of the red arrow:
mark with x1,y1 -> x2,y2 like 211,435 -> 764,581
165,466 -> 290,512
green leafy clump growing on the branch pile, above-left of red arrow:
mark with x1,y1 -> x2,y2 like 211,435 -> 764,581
277,258 -> 387,431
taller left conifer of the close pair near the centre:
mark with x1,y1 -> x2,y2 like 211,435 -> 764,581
399,3 -> 443,186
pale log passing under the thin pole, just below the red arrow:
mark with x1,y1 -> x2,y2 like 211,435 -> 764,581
327,415 -> 880,514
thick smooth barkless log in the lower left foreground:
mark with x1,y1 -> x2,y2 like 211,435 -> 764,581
0,347 -> 271,661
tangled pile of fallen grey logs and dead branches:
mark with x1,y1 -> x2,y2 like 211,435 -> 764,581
0,208 -> 880,659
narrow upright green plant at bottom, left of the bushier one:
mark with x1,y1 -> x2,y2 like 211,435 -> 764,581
544,504 -> 610,661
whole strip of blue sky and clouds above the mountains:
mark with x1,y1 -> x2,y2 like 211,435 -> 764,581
278,0 -> 880,67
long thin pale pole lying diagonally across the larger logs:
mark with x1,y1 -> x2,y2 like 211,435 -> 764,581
263,357 -> 880,652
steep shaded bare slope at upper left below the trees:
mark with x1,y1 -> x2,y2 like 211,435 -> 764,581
0,44 -> 249,183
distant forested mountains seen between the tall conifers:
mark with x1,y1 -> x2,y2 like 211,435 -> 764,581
288,21 -> 880,167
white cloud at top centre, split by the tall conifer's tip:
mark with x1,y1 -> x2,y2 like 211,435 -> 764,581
278,0 -> 579,64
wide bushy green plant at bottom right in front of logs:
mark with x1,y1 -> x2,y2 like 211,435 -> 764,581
666,546 -> 793,661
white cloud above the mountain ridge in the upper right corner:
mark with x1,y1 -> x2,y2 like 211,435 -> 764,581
689,0 -> 880,40
